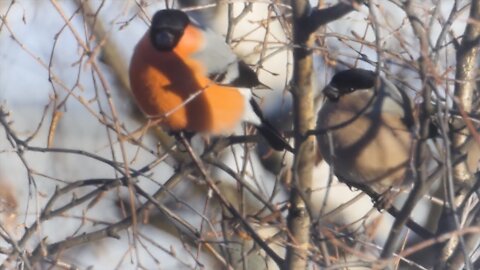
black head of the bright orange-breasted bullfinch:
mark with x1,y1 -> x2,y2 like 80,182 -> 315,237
150,9 -> 190,51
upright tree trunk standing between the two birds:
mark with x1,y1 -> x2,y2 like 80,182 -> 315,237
285,0 -> 315,269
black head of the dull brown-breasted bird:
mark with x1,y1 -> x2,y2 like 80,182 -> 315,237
323,68 -> 376,101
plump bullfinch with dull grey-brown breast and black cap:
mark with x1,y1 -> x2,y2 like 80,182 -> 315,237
317,69 -> 415,199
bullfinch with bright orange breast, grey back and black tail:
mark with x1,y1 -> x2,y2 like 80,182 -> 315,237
129,9 -> 292,150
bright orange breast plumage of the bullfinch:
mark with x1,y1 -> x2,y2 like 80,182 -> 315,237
130,26 -> 245,134
